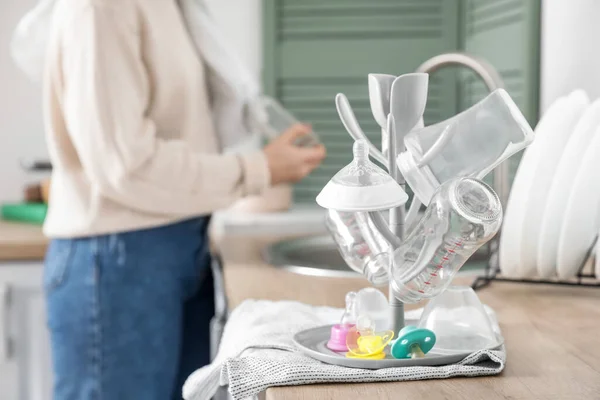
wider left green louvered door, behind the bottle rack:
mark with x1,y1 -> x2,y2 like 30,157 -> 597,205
264,0 -> 459,203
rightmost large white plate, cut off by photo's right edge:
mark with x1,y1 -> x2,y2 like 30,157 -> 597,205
556,129 -> 600,279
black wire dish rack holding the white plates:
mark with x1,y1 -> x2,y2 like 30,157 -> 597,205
471,235 -> 600,290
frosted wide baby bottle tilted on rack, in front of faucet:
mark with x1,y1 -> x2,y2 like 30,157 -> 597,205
397,89 -> 533,204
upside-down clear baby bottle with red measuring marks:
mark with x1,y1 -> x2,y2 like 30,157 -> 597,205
390,178 -> 502,303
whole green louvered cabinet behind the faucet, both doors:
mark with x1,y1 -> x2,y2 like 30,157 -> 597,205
263,0 -> 540,203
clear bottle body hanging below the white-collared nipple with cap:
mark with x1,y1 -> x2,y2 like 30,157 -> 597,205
325,209 -> 392,286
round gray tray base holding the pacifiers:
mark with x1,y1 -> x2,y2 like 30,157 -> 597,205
294,320 -> 504,369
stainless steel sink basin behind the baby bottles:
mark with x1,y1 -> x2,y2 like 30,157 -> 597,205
264,235 -> 489,279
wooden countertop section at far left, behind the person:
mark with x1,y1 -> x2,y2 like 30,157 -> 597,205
0,221 -> 48,262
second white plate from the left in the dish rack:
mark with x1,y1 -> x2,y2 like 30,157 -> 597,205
516,90 -> 590,277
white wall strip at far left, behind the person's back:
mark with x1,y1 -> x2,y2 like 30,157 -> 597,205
0,0 -> 47,202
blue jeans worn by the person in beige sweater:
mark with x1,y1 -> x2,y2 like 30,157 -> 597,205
44,218 -> 214,400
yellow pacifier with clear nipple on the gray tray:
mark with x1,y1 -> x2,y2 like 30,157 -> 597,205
346,315 -> 394,360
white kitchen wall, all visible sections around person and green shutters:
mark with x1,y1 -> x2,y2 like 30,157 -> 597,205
0,0 -> 600,201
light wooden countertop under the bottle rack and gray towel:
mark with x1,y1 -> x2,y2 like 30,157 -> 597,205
219,234 -> 600,400
